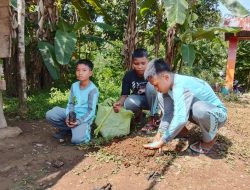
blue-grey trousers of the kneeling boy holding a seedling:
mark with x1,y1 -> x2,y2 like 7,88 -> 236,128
46,106 -> 91,144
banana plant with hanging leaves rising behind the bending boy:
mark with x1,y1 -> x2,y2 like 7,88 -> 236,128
163,0 -> 247,66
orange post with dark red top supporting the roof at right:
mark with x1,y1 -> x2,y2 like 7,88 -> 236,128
226,36 -> 238,90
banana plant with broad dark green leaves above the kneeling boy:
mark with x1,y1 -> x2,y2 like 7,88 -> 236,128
38,20 -> 115,80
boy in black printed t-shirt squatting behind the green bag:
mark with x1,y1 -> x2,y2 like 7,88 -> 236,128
113,48 -> 157,131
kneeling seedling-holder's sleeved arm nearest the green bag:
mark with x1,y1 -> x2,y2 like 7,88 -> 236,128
77,88 -> 99,125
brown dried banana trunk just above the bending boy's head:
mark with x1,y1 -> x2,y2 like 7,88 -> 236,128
165,26 -> 176,68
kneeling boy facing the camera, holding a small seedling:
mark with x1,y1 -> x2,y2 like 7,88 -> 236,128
46,59 -> 99,144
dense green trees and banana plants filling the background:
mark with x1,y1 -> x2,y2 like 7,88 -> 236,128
4,0 -> 250,119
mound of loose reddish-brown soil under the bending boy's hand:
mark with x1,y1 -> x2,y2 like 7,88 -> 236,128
100,136 -> 188,167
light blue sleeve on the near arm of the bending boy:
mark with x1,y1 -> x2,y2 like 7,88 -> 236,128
162,88 -> 194,142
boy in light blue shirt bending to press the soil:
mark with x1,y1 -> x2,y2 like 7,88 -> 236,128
144,59 -> 227,154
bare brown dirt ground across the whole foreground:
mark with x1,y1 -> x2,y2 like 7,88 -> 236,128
0,100 -> 250,190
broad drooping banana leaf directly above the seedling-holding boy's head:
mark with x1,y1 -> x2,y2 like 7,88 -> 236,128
54,30 -> 77,65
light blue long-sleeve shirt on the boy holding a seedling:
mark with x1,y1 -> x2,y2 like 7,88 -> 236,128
66,81 -> 99,125
